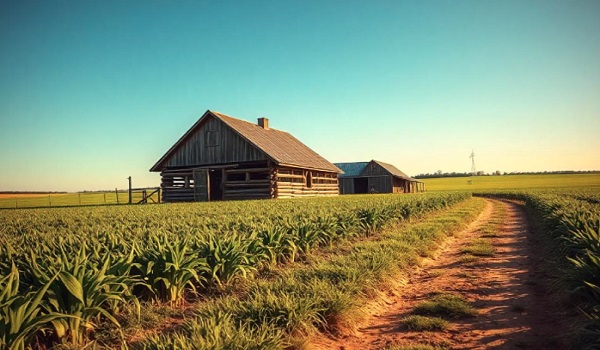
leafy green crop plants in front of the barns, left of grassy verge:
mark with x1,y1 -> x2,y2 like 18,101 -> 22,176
0,194 -> 469,349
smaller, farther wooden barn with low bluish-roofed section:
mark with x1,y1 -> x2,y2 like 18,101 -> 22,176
335,160 -> 425,194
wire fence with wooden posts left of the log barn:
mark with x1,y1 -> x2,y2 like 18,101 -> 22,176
0,188 -> 160,209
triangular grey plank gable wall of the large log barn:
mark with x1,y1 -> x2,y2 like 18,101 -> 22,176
165,116 -> 268,168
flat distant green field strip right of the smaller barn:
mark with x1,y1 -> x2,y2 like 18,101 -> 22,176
422,174 -> 600,191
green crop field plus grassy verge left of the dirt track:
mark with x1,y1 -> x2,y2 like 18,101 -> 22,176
0,193 -> 480,348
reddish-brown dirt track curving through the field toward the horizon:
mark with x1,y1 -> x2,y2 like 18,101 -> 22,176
309,199 -> 567,350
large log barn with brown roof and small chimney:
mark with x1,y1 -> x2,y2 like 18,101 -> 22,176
150,110 -> 341,202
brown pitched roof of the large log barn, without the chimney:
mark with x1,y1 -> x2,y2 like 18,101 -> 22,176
150,110 -> 342,173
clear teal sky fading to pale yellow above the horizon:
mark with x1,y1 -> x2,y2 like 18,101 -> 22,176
0,0 -> 600,191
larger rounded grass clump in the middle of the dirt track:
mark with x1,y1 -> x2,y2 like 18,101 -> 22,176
413,293 -> 478,318
